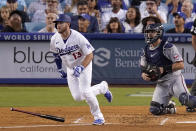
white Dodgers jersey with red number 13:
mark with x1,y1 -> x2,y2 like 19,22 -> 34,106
50,29 -> 94,69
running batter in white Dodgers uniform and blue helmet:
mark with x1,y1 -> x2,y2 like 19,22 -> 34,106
50,14 -> 112,125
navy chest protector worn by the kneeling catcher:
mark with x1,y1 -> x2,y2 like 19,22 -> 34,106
145,41 -> 172,67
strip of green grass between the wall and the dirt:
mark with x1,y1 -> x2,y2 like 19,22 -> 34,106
0,87 -> 179,107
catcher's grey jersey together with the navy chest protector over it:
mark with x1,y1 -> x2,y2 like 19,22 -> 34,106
140,41 -> 183,80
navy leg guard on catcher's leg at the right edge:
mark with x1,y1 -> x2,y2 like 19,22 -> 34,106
179,93 -> 196,108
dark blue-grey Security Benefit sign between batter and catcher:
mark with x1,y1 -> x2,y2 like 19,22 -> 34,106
92,40 -> 144,83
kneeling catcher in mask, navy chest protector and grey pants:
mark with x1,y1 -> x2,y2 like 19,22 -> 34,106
141,24 -> 196,115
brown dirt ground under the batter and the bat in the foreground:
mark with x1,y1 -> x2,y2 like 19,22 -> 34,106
0,106 -> 196,131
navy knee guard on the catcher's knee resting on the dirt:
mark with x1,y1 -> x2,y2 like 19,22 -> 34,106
150,101 -> 164,115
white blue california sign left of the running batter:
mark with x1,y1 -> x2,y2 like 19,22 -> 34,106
0,41 -> 59,78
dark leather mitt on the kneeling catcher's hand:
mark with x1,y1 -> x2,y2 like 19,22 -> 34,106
144,65 -> 161,81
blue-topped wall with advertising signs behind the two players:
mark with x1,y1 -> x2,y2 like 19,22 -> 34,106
0,33 -> 196,84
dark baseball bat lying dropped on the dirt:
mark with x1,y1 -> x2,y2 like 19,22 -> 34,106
10,107 -> 65,122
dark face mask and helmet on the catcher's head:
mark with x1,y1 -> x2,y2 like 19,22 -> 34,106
144,23 -> 164,44
